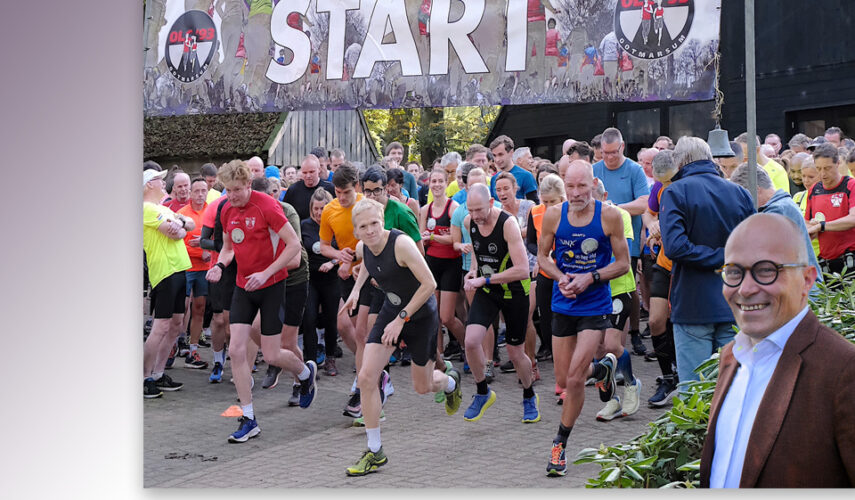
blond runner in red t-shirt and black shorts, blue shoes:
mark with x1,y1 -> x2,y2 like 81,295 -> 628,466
208,160 -> 318,443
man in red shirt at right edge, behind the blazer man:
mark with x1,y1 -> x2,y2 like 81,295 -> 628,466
805,144 -> 855,273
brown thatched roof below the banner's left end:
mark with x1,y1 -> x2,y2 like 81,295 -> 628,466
143,113 -> 282,158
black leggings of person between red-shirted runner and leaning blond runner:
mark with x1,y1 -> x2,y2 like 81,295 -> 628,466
300,278 -> 340,361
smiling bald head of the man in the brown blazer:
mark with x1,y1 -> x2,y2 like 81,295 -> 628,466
722,214 -> 816,343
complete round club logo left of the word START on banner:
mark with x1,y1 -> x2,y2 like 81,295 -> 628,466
166,10 -> 217,83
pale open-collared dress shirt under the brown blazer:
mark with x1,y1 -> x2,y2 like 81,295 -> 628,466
710,307 -> 808,488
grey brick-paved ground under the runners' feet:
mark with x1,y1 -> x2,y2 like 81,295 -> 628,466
143,328 -> 665,488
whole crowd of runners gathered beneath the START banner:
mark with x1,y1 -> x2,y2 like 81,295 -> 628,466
143,127 -> 855,476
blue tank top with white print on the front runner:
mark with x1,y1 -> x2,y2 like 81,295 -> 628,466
552,200 -> 612,316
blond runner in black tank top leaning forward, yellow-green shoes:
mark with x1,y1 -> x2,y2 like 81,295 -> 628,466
340,199 -> 461,476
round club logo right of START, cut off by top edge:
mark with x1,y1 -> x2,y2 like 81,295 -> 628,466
615,0 -> 695,59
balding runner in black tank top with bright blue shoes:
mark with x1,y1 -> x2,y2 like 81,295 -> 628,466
463,184 -> 540,423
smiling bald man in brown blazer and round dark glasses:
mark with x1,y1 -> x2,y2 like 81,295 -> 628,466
701,214 -> 855,488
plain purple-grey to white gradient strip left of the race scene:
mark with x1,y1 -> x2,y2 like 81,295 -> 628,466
0,0 -> 824,499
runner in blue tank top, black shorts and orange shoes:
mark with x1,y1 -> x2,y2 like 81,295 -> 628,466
537,160 -> 629,476
